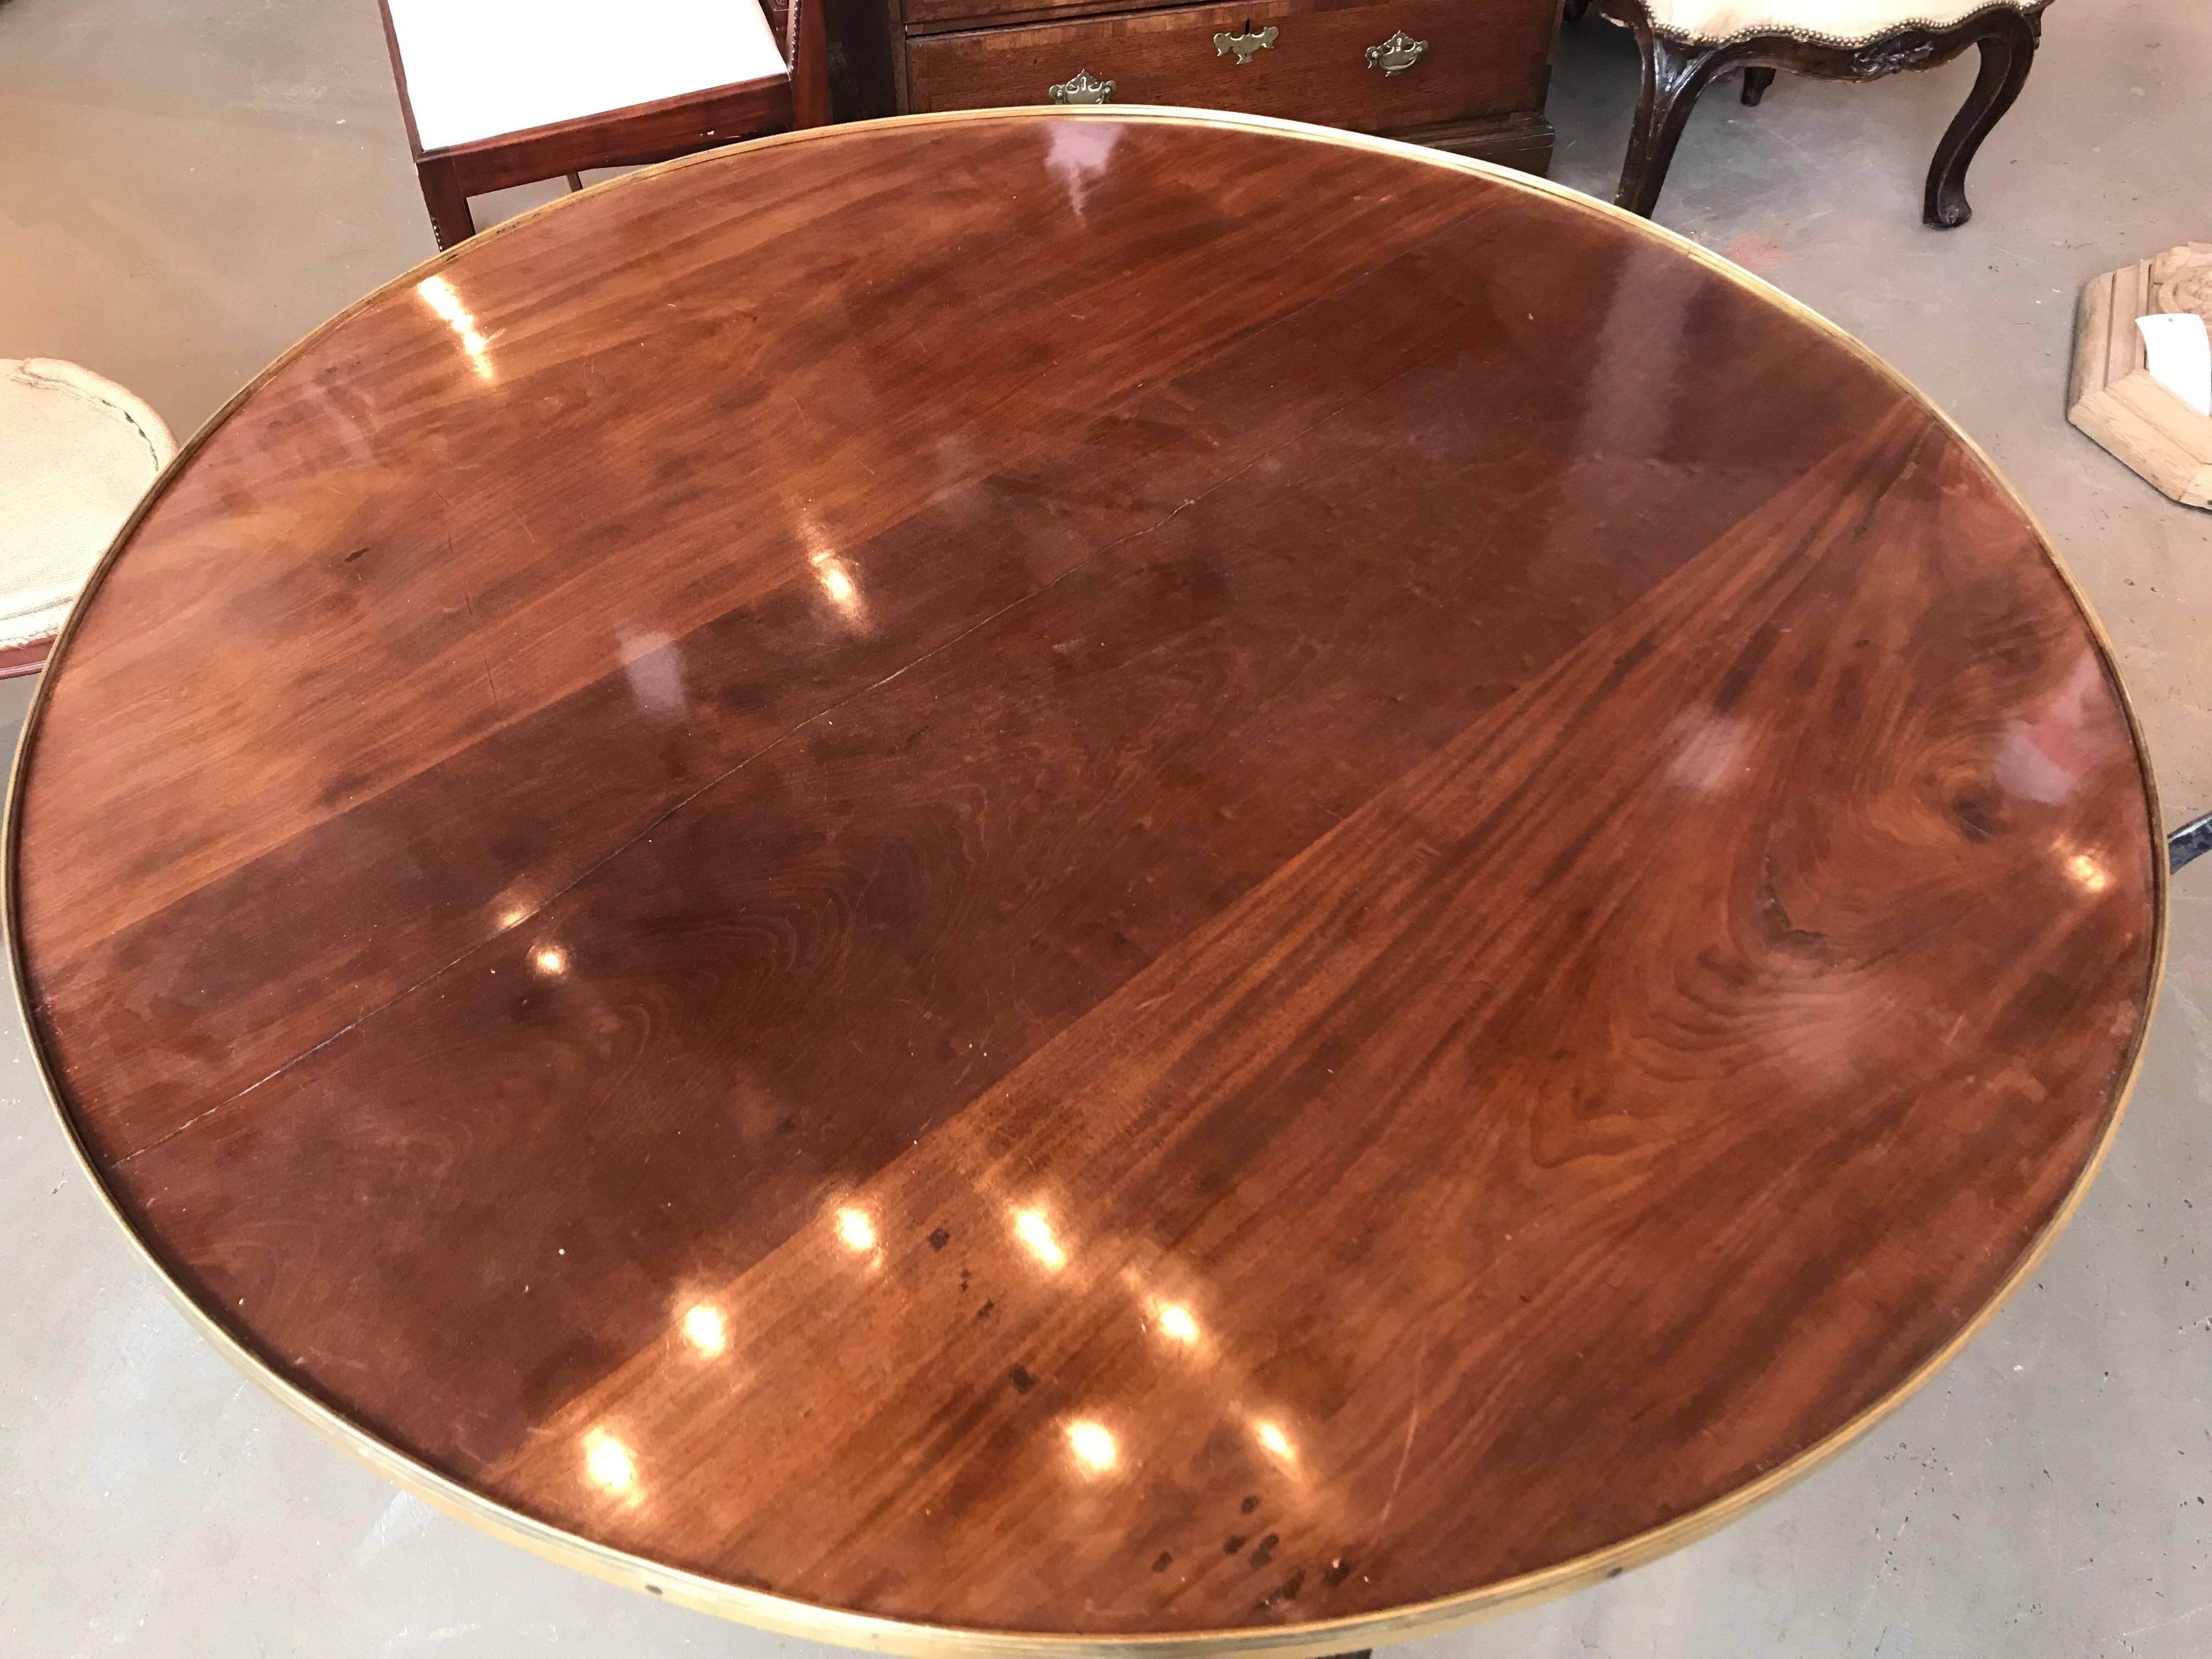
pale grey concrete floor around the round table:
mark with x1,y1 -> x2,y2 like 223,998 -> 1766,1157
0,0 -> 2212,1659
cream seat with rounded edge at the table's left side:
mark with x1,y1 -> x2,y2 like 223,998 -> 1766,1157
0,356 -> 177,648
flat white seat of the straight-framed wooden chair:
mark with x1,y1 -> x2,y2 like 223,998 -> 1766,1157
387,0 -> 789,150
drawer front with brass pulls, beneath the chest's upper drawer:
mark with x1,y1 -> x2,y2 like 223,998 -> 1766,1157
907,0 -> 1558,133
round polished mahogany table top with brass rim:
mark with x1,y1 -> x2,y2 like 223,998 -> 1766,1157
9,109 -> 2165,1652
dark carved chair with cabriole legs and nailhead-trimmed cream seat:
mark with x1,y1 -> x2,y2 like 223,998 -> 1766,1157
1566,0 -> 2049,230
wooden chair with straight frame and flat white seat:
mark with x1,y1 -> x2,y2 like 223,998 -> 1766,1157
378,0 -> 830,248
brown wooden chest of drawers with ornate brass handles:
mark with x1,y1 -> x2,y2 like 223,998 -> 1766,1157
827,0 -> 1560,172
